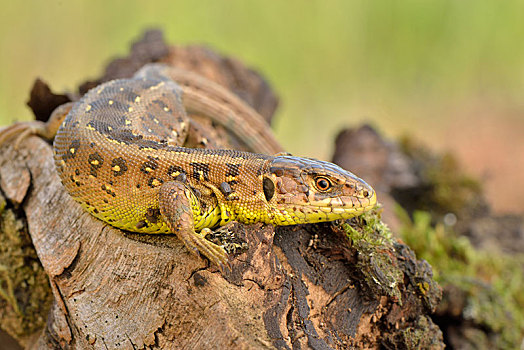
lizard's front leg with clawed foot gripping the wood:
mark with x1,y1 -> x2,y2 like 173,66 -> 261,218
159,181 -> 228,270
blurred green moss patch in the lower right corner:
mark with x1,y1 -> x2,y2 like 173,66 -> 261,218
396,207 -> 524,349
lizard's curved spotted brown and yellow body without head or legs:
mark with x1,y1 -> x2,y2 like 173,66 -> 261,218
54,73 -> 273,233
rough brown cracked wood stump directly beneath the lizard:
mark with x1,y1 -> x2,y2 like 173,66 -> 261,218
1,137 -> 441,349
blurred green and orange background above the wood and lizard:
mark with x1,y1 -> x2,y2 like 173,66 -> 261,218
0,0 -> 524,212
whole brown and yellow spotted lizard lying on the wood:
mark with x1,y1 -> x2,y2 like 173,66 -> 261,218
0,64 -> 377,269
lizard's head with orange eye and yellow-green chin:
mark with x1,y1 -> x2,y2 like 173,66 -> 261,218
263,156 -> 377,225
